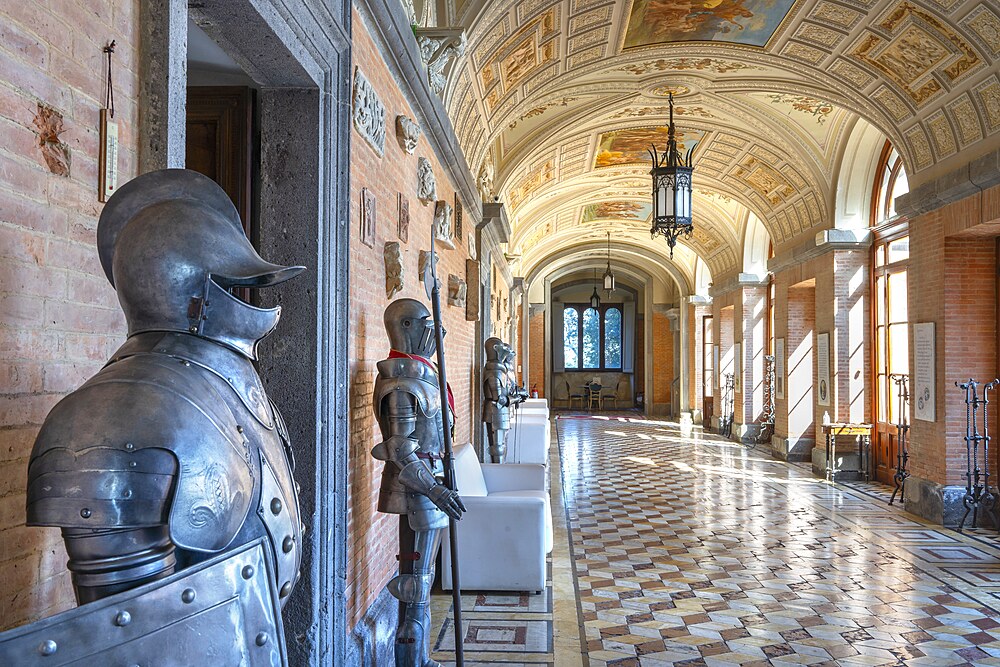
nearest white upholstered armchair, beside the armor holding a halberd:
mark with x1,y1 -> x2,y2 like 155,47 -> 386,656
441,444 -> 552,591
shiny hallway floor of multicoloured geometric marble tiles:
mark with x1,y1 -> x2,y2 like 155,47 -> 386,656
555,417 -> 1000,667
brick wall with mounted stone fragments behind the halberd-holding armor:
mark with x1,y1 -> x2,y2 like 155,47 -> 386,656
347,12 -> 476,628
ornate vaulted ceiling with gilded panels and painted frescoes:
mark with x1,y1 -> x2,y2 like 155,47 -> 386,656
445,0 -> 1000,284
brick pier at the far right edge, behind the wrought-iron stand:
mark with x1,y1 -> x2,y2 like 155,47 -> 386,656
907,186 -> 1000,485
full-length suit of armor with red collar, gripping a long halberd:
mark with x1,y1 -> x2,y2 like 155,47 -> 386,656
372,299 -> 465,667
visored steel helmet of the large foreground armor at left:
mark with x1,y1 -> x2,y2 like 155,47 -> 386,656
97,169 -> 304,359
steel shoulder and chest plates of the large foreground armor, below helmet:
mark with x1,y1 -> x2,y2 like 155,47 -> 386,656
27,333 -> 301,602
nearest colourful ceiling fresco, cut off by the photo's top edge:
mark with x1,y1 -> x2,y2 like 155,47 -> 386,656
625,0 -> 794,49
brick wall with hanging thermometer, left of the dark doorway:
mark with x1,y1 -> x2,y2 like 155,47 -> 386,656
0,0 -> 138,630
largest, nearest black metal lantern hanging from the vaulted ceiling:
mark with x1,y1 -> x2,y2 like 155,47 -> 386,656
649,93 -> 694,259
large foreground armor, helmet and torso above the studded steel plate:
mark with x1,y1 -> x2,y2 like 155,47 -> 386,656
1,169 -> 302,660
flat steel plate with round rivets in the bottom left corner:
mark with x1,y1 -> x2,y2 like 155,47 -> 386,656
0,540 -> 288,667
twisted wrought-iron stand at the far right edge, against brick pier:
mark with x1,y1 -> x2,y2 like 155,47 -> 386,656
955,378 -> 1000,532
